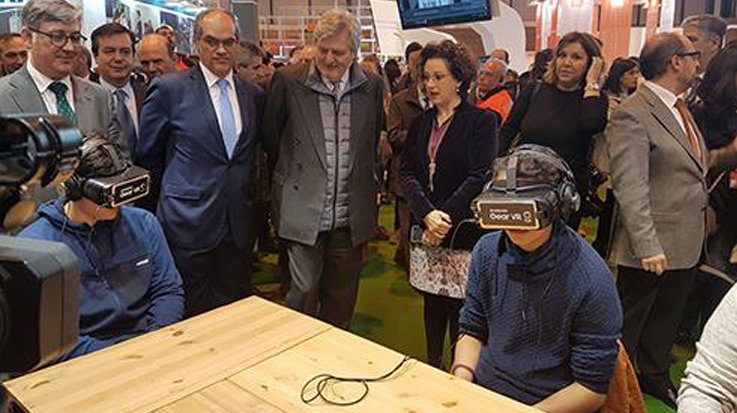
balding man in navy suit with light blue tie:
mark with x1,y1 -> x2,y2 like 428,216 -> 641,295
134,9 -> 264,316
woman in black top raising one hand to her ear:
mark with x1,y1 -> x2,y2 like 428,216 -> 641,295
500,32 -> 607,229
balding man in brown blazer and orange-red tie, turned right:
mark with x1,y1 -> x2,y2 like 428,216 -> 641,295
606,33 -> 737,407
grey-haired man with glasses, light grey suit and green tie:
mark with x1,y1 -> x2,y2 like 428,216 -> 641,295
0,0 -> 119,148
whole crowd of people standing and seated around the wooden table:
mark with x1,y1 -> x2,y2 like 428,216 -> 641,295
0,0 -> 737,412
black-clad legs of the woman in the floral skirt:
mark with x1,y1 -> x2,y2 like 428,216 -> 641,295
423,293 -> 463,369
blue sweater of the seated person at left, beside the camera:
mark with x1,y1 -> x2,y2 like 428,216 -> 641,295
19,199 -> 184,361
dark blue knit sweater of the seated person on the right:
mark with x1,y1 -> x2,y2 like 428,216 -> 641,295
459,225 -> 622,404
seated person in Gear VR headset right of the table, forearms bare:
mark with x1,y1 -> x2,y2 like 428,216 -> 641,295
451,144 -> 622,412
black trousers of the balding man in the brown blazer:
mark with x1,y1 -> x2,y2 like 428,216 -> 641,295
617,266 -> 696,382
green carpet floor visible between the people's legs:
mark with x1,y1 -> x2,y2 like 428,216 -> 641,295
254,206 -> 693,413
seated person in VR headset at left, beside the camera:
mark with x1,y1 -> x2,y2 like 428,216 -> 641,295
19,134 -> 184,361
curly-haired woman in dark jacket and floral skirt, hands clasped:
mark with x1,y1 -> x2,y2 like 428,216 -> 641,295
401,41 -> 497,367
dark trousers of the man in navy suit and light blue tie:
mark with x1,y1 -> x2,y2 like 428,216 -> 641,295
171,239 -> 251,317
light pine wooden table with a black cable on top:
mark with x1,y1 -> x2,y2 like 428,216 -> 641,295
3,297 -> 537,413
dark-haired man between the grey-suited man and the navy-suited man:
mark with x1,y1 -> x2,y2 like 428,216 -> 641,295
90,23 -> 146,157
